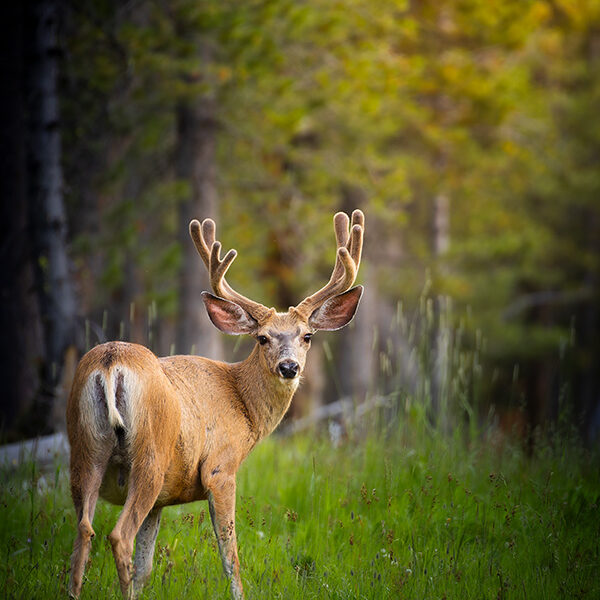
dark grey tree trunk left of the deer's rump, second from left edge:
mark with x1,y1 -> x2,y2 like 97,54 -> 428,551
28,1 -> 77,433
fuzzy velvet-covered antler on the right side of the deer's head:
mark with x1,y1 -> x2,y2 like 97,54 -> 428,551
296,209 -> 365,315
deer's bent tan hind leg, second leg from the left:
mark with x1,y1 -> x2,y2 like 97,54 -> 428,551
108,464 -> 164,599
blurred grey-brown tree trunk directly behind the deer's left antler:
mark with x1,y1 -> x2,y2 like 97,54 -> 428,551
175,93 -> 222,358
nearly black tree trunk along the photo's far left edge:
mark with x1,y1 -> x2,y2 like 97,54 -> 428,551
0,2 -> 42,436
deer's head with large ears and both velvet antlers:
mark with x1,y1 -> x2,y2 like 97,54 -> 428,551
190,210 -> 364,385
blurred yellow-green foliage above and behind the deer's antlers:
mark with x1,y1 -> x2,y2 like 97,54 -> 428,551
63,0 -> 600,418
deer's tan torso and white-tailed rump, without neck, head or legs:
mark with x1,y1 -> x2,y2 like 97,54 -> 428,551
67,342 -> 261,506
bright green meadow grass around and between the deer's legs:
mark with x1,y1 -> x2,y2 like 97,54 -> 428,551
0,423 -> 600,600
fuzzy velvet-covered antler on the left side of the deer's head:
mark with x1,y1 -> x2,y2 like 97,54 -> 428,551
190,219 -> 271,321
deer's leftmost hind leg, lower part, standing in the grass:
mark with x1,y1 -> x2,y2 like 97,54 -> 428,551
69,460 -> 106,598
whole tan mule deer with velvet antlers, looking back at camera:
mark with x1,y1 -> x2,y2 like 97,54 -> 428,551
67,210 -> 364,599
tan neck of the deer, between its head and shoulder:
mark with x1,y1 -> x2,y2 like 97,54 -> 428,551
232,346 -> 299,441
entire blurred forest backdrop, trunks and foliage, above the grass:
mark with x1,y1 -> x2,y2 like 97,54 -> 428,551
1,0 -> 600,436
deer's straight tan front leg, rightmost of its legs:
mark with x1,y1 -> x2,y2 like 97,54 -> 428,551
208,475 -> 244,600
